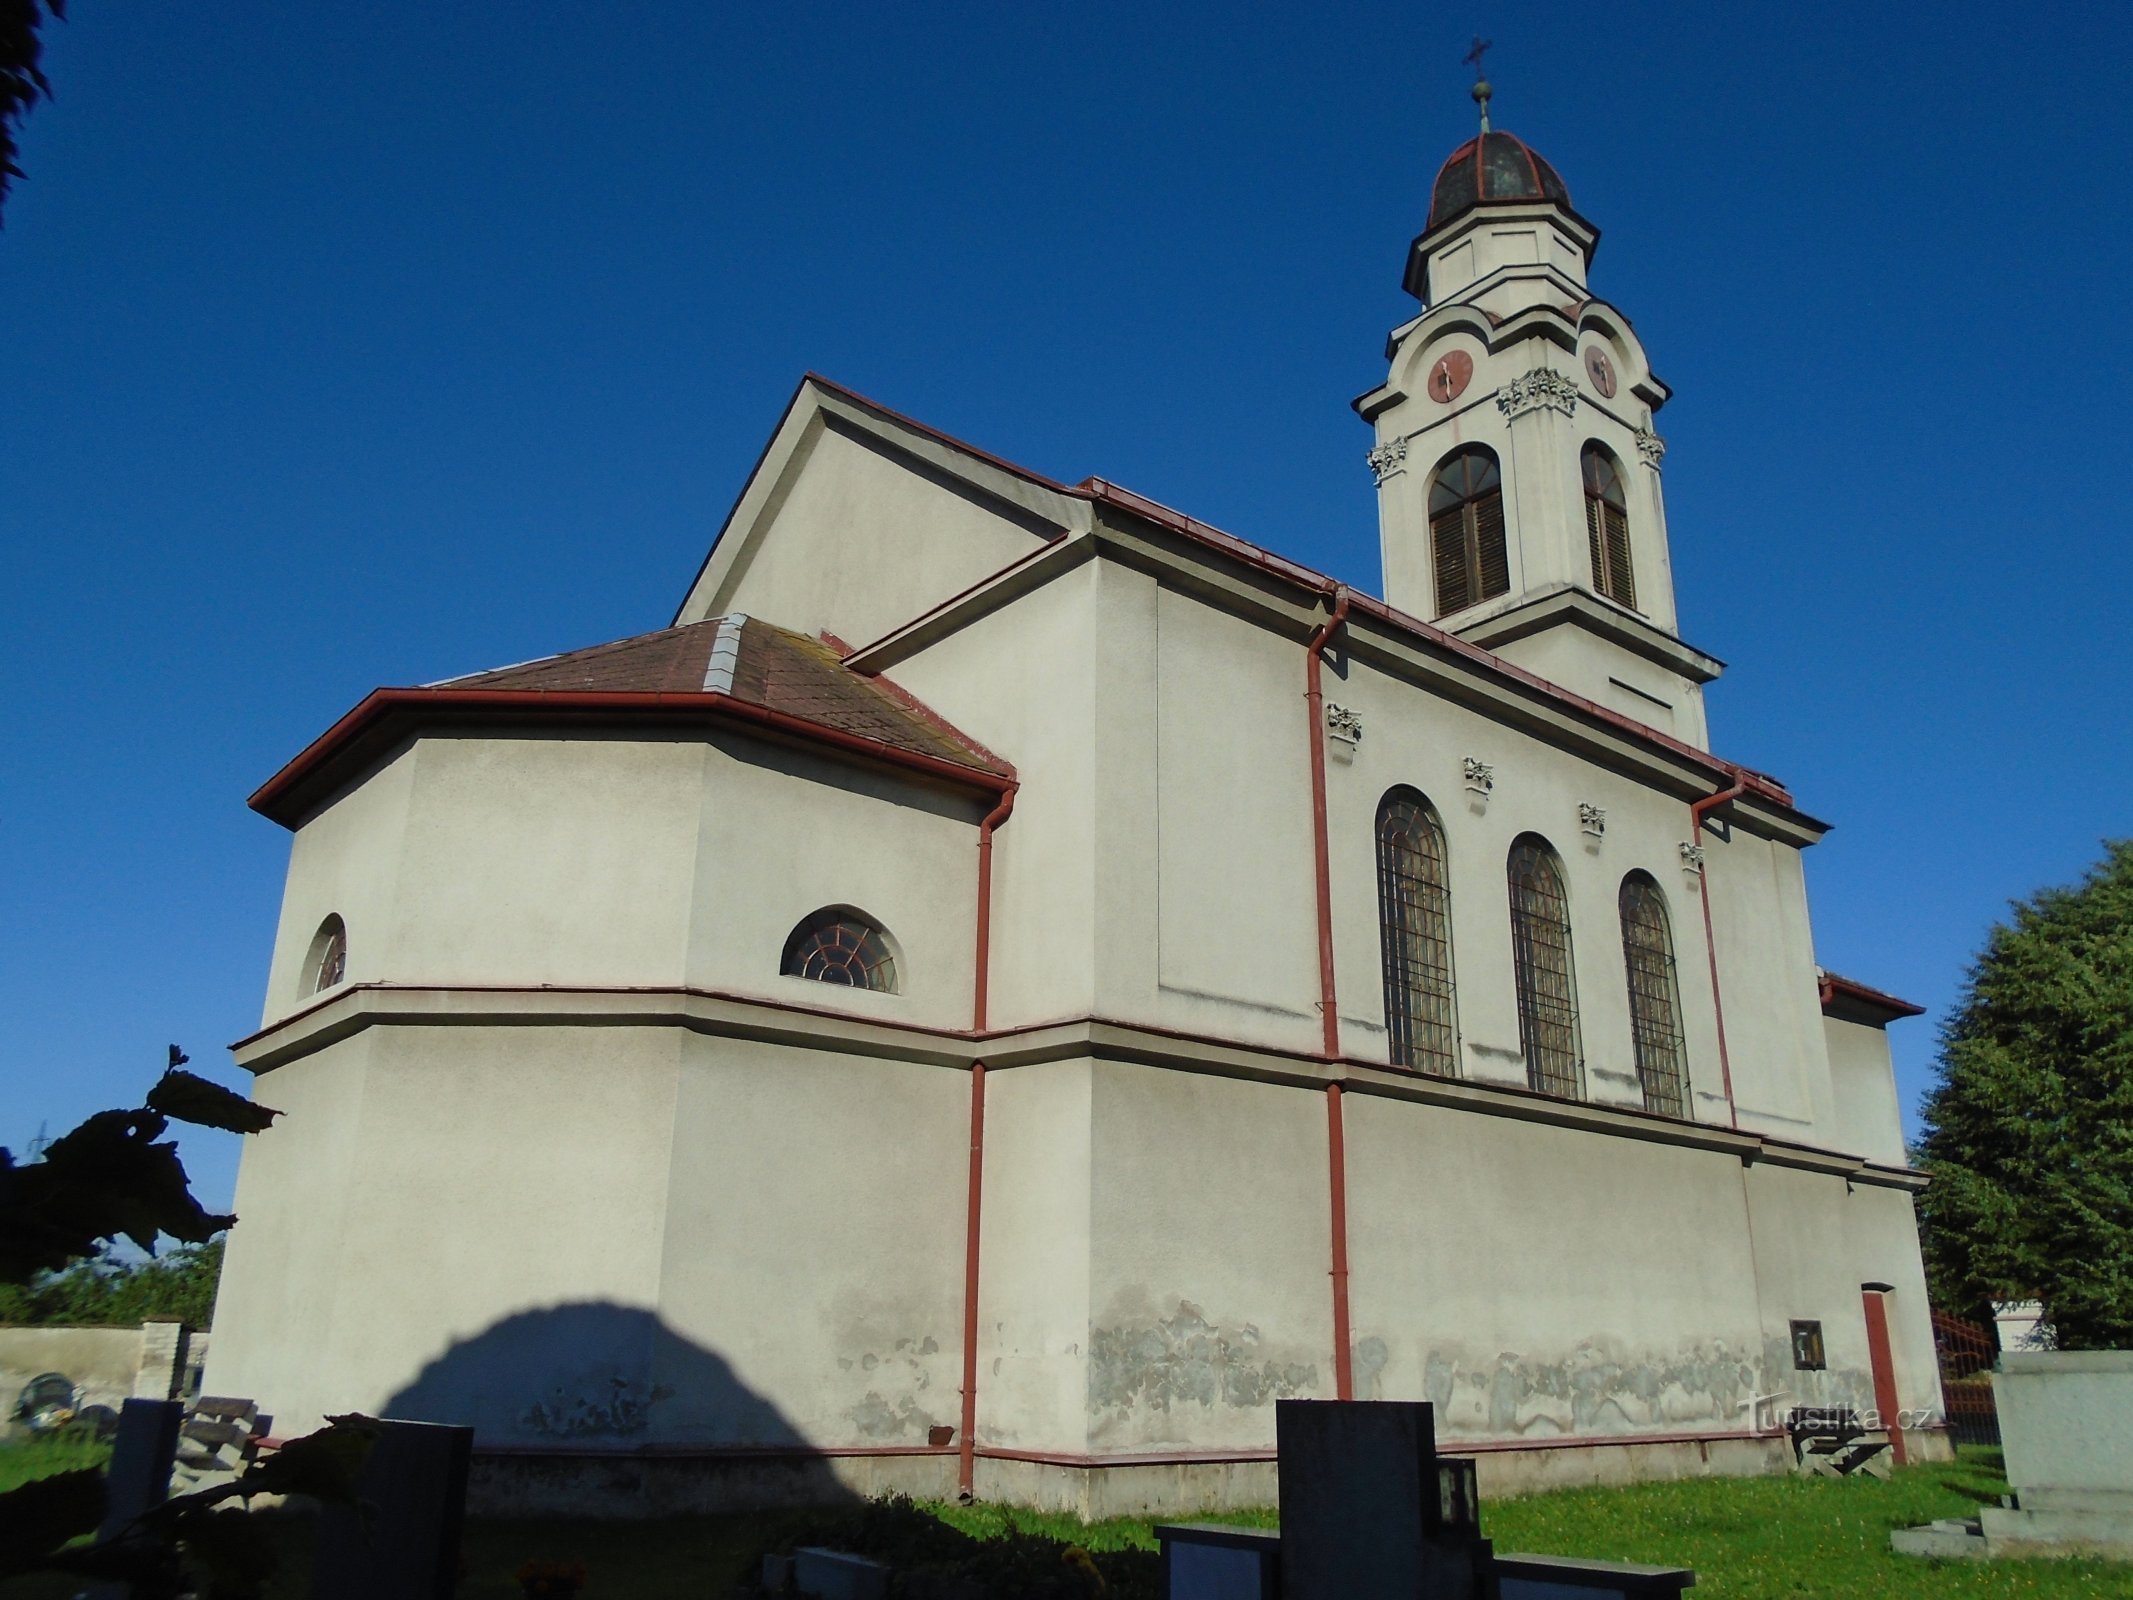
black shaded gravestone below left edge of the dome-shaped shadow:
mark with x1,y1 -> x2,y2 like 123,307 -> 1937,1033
311,1421 -> 474,1600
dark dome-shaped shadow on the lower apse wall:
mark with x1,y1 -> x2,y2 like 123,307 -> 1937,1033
384,1301 -> 808,1451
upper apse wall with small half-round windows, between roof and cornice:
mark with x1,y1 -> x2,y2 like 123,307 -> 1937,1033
267,732 -> 983,1026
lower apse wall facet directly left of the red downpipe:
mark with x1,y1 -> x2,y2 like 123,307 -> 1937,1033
651,1037 -> 968,1446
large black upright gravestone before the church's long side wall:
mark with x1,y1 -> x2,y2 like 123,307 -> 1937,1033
1273,1399 -> 1489,1600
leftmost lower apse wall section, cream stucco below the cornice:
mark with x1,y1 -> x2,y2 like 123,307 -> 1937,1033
205,1026 -> 680,1438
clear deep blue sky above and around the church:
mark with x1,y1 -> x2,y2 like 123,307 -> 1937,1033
0,0 -> 2133,1201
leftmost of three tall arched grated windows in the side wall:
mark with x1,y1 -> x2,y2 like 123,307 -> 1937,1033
1378,789 -> 1459,1077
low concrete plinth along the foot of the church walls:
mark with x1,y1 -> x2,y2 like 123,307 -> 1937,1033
467,1438 -> 1792,1521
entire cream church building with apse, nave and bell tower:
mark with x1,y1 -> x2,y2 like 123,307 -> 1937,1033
207,92 -> 1947,1515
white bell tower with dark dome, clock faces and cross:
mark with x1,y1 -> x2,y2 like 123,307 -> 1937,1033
1354,81 -> 1723,749
